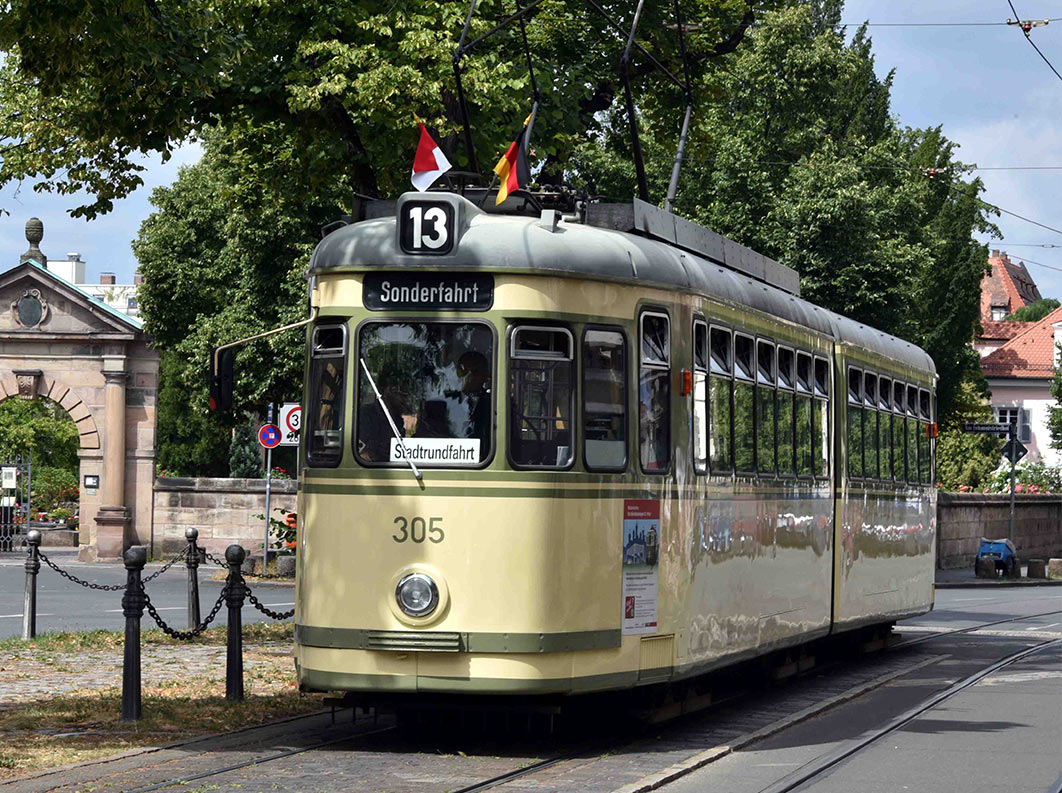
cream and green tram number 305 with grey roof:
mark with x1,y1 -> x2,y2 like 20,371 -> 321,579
295,192 -> 936,695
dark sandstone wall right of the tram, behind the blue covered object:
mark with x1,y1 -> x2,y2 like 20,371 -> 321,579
937,493 -> 1062,569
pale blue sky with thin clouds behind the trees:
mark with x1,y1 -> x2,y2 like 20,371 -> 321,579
0,0 -> 1062,299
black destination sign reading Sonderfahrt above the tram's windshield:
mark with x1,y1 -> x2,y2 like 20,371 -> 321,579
362,273 -> 494,311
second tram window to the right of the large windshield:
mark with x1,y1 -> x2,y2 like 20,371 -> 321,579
583,328 -> 627,471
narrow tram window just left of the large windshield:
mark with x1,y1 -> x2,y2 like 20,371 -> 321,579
306,325 -> 347,467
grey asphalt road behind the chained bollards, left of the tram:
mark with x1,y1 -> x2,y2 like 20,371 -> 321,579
0,548 -> 295,639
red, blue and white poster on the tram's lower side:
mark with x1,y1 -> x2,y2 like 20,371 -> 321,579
621,499 -> 661,636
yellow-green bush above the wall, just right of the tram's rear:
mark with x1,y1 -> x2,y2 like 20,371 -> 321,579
937,375 -> 1004,490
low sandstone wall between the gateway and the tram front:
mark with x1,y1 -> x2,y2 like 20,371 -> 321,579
150,477 -> 296,558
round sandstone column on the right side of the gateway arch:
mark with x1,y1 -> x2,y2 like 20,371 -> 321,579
96,356 -> 130,558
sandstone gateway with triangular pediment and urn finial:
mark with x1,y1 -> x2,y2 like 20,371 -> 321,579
0,221 -> 158,561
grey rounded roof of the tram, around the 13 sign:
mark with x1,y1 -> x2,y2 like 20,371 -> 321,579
310,192 -> 936,374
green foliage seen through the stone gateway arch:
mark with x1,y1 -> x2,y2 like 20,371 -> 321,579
0,399 -> 80,475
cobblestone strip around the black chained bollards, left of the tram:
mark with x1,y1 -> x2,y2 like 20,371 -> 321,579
0,642 -> 294,708
